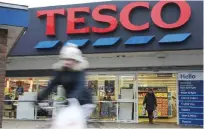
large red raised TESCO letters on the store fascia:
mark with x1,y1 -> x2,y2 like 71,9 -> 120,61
37,0 -> 191,36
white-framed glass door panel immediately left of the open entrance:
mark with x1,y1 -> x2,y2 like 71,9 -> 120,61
117,74 -> 137,122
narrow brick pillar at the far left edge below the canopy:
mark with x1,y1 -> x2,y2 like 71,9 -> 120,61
0,29 -> 7,128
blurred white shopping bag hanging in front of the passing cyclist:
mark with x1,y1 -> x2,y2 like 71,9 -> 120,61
51,99 -> 87,129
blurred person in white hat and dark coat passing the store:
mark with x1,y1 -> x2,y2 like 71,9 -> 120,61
37,43 -> 94,118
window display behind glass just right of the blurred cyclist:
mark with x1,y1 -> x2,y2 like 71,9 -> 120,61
87,75 -> 117,120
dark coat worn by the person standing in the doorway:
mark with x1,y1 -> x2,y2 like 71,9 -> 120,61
143,93 -> 157,111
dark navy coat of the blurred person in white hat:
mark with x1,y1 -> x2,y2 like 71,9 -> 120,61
38,70 -> 92,105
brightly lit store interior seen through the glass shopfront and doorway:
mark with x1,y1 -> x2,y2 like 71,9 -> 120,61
4,73 -> 177,123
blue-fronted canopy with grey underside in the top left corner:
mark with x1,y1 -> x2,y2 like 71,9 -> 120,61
0,2 -> 29,54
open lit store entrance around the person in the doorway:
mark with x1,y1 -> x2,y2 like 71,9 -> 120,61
137,73 -> 177,123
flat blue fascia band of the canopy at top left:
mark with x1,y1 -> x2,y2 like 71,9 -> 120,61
0,7 -> 29,27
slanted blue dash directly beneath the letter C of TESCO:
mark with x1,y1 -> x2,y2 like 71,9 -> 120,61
124,36 -> 154,45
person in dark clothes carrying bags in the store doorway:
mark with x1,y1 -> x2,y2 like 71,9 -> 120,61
143,89 -> 157,124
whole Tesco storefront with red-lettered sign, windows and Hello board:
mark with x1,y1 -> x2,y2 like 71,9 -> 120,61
5,1 -> 203,125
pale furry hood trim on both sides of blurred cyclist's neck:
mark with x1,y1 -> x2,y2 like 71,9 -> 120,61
52,58 -> 89,71
